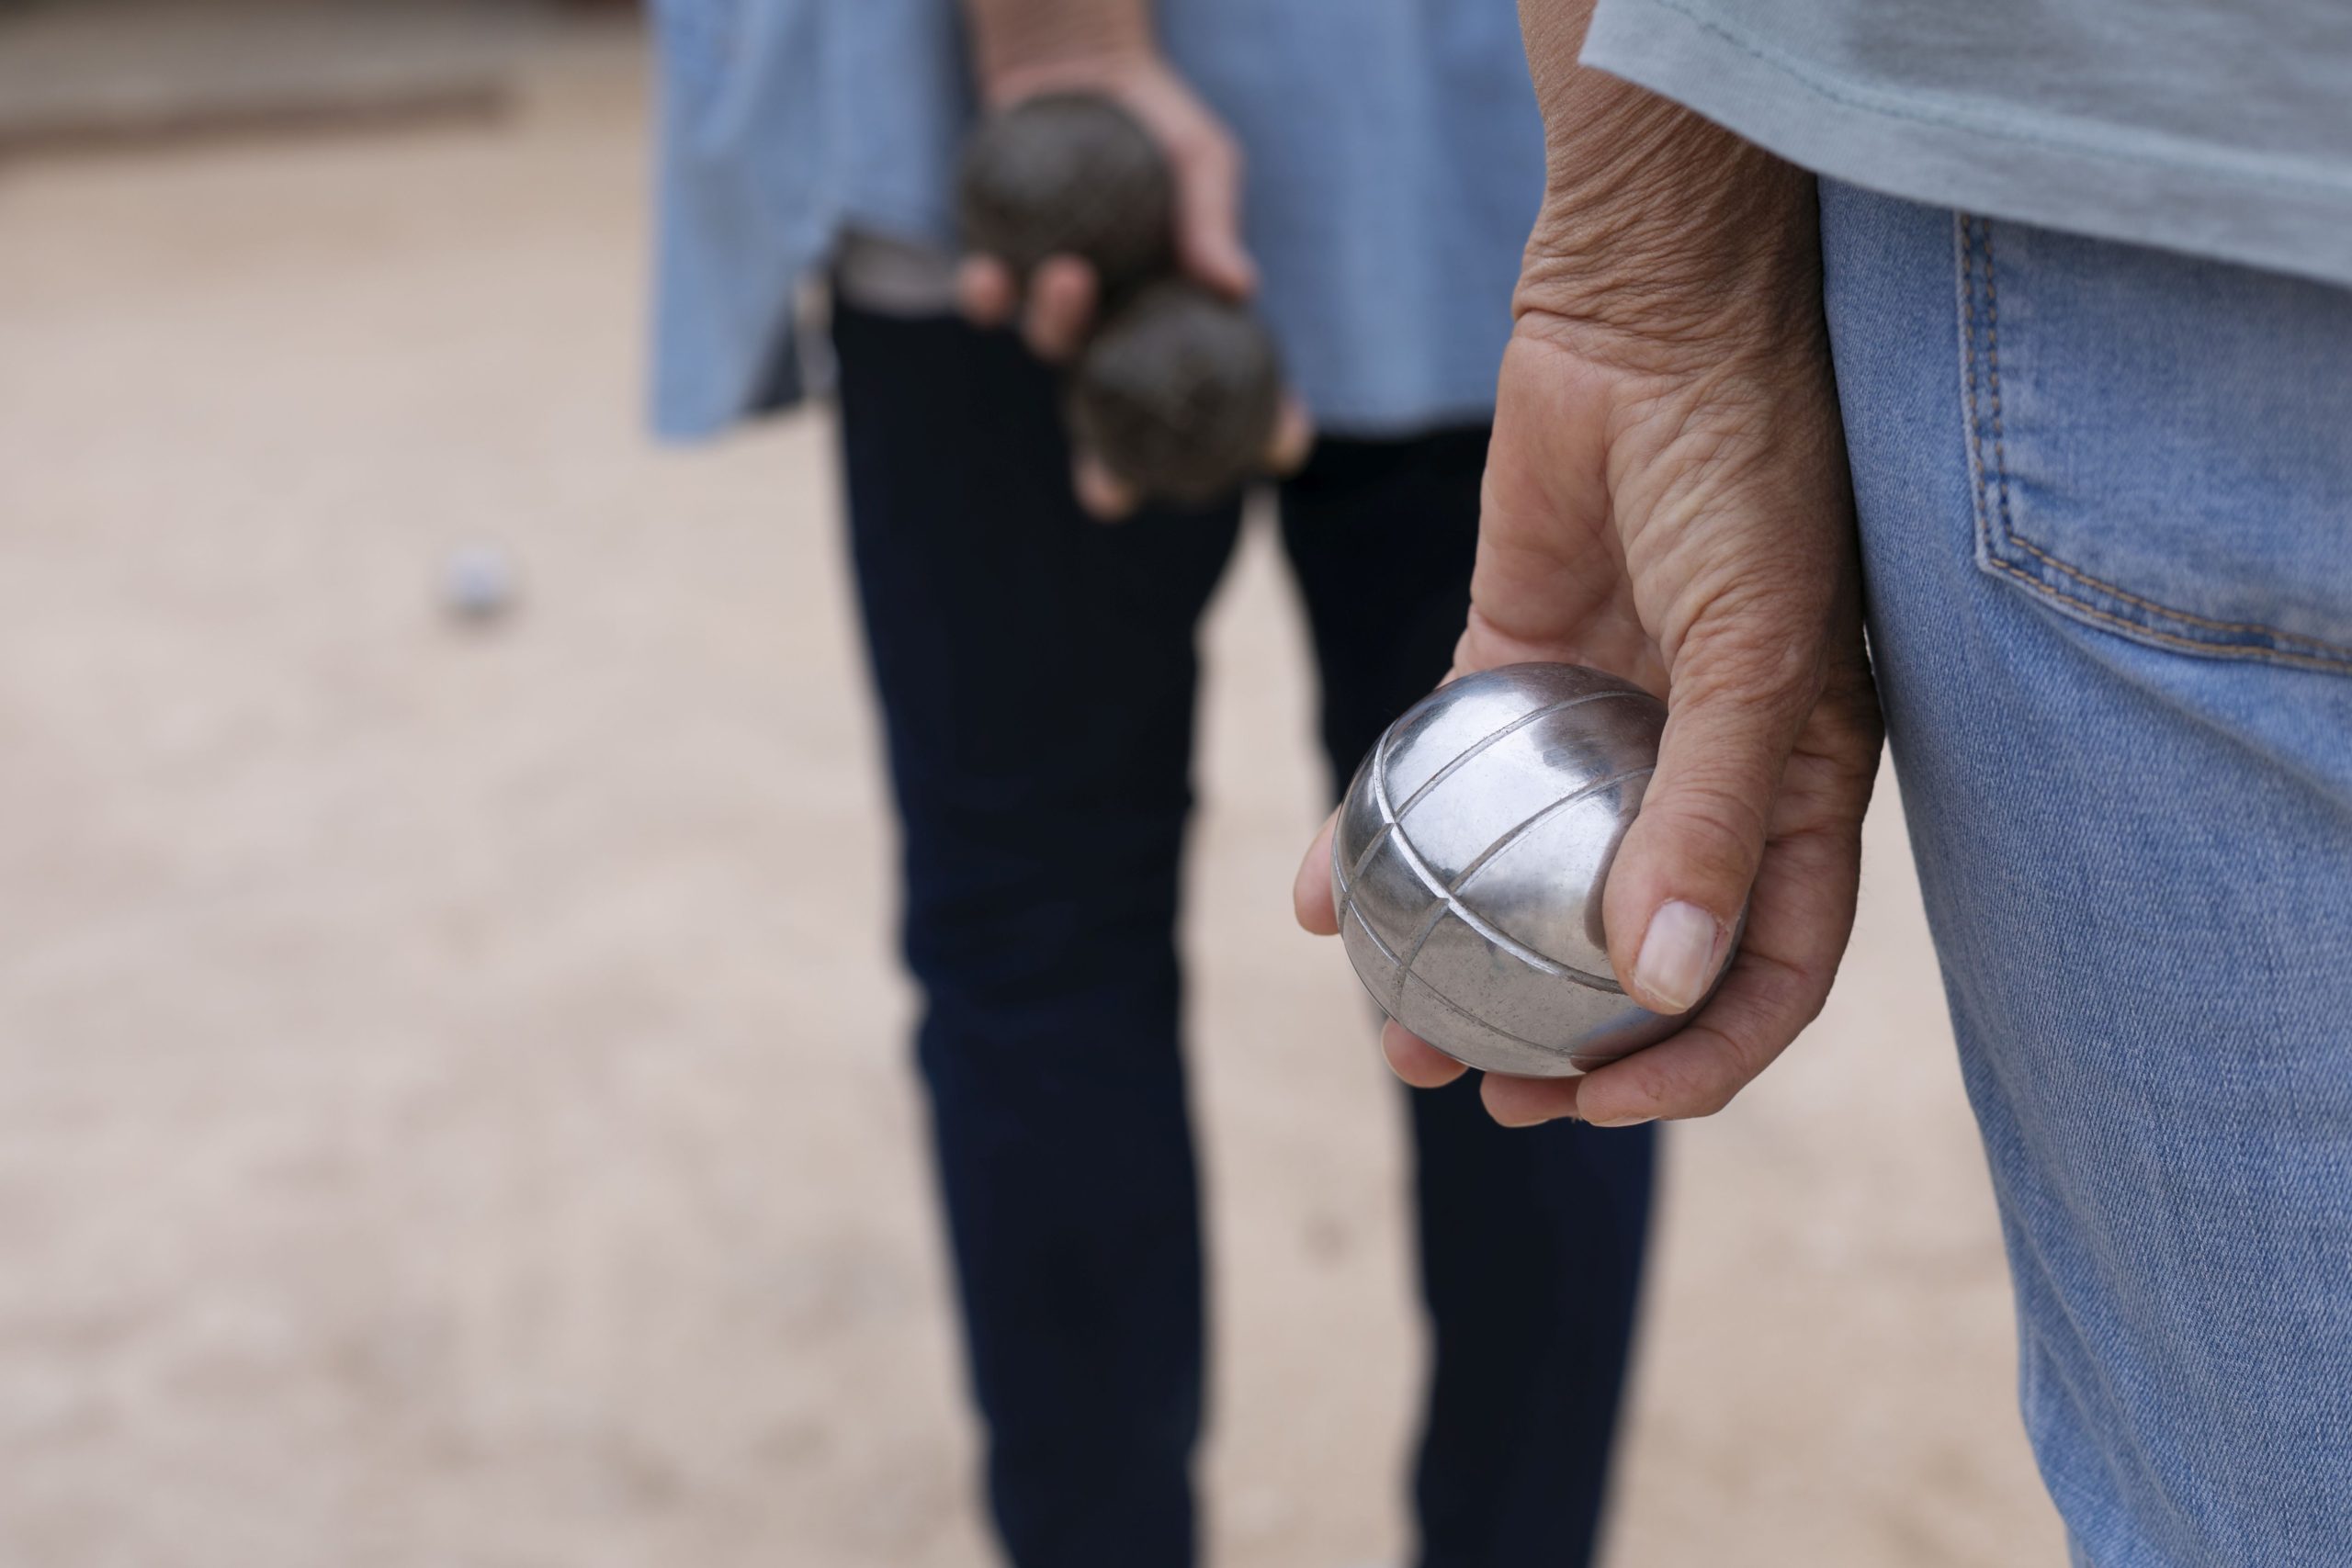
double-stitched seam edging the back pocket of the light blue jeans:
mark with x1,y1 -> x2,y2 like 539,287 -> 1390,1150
1959,214 -> 2352,672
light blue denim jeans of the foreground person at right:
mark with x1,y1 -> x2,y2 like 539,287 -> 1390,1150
1823,184 -> 2352,1568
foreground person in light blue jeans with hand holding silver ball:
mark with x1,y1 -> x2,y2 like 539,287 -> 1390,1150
1298,0 -> 2352,1568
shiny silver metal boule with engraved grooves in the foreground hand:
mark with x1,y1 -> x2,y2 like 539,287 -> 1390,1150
1331,665 -> 1681,1077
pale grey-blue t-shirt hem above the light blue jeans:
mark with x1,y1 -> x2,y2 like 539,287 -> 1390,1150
1583,0 -> 2352,285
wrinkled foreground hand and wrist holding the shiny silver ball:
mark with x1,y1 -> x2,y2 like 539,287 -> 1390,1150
1296,73 -> 1879,1126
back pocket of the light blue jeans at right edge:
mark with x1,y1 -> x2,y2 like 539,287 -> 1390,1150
1954,216 -> 2352,670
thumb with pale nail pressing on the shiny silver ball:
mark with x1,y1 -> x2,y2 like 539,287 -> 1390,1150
1601,627 -> 1820,1013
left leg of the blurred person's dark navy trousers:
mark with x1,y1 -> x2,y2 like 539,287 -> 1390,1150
835,306 -> 1238,1568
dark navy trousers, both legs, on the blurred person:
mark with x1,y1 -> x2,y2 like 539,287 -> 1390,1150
832,306 -> 1654,1568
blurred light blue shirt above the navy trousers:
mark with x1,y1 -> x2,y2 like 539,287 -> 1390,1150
651,0 -> 1543,437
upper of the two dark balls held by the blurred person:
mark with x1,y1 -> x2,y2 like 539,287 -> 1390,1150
957,92 -> 1176,299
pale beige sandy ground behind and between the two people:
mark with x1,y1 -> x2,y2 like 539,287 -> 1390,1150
0,21 -> 2058,1568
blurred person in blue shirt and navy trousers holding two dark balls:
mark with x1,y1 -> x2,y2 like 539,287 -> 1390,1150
635,0 -> 1654,1568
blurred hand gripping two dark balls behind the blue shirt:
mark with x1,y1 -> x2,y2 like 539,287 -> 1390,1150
955,0 -> 1315,520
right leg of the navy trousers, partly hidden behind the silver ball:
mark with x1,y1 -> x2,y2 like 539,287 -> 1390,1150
1282,428 -> 1656,1568
